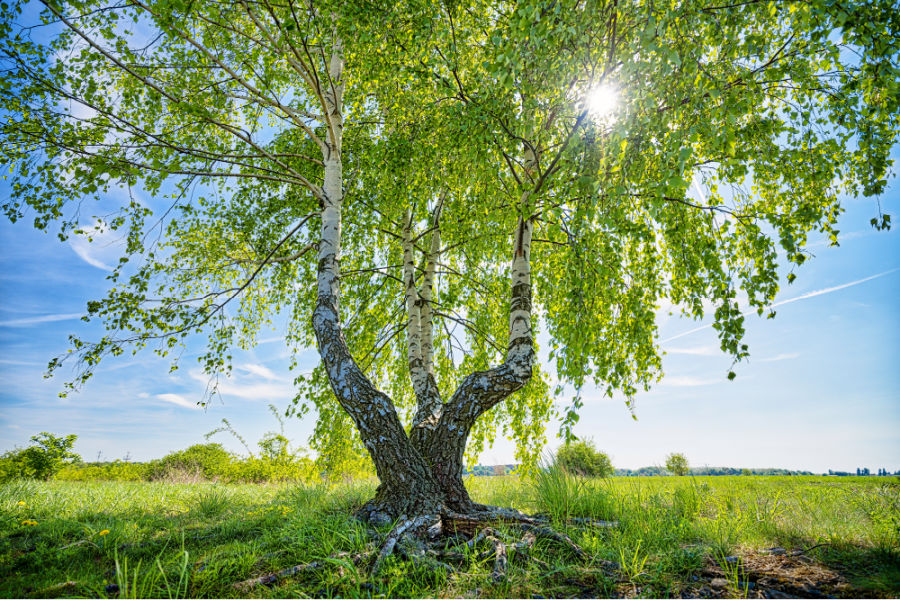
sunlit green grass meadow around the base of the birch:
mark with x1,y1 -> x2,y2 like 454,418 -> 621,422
0,470 -> 900,598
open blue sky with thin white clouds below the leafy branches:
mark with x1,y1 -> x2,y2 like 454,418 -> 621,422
0,173 -> 900,472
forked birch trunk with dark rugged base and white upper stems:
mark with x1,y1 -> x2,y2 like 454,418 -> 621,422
312,32 -> 534,523
